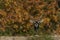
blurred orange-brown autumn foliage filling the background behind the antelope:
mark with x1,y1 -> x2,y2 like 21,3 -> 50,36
0,0 -> 60,35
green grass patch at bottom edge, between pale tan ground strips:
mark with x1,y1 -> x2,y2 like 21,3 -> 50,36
27,34 -> 54,40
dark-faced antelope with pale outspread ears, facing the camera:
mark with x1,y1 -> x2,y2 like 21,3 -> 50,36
30,15 -> 44,32
